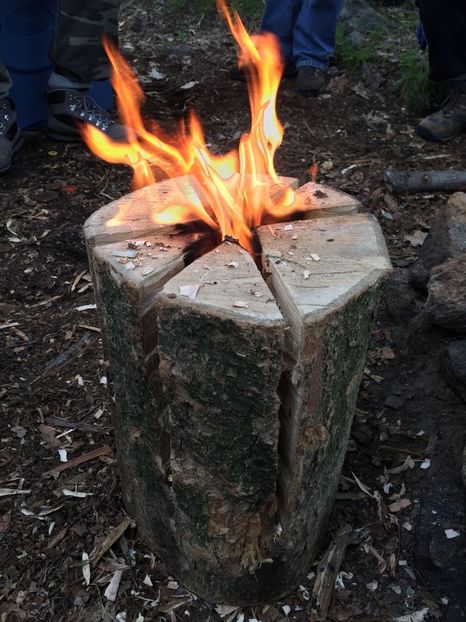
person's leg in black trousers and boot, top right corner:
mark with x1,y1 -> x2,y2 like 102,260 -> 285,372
416,0 -> 466,142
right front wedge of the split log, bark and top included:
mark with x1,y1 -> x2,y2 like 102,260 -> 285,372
258,214 -> 390,600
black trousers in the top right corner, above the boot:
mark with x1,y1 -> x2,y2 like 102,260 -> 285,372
418,0 -> 466,81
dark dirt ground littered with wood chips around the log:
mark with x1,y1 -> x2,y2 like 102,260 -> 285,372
0,2 -> 466,622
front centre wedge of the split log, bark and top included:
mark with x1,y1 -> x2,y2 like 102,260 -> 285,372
153,243 -> 285,602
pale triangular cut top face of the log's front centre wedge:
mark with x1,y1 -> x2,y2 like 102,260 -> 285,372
157,242 -> 282,324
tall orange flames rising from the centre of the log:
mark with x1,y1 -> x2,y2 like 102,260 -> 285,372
84,0 -> 297,251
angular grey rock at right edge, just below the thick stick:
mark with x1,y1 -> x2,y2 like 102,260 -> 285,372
411,192 -> 466,289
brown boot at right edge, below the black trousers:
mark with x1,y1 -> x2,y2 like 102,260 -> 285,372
416,90 -> 466,143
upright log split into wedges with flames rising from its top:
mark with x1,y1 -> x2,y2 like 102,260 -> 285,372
85,180 -> 390,604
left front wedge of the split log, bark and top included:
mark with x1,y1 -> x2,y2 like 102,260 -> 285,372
90,226 -> 215,558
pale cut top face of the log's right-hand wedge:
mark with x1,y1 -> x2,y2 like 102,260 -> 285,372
258,214 -> 390,320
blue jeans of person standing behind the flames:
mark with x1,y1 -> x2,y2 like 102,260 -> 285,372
261,0 -> 343,71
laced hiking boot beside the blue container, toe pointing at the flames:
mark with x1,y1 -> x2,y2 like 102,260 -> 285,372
47,89 -> 127,141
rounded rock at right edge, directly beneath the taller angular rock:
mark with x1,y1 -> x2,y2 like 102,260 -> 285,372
424,253 -> 466,333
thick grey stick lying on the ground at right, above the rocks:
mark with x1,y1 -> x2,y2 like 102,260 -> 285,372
384,170 -> 466,193
